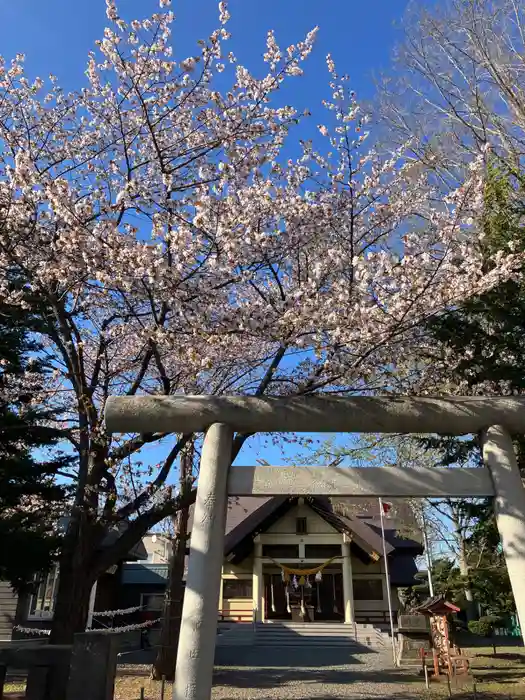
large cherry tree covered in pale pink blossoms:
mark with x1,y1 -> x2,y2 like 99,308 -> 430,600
0,0 -> 519,656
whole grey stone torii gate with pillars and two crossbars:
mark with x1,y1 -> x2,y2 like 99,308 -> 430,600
105,396 -> 525,700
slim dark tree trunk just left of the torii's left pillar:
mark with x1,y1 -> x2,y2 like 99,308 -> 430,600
151,447 -> 193,681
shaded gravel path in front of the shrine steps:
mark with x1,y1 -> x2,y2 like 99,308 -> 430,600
213,648 -> 424,700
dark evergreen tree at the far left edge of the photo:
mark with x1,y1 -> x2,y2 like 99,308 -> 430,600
0,288 -> 70,590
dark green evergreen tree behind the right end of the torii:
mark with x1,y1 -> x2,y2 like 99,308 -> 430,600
422,160 -> 525,470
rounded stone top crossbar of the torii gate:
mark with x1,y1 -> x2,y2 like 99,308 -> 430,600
105,395 -> 525,435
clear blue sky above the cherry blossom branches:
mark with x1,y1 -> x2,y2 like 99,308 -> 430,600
0,0 -> 422,464
